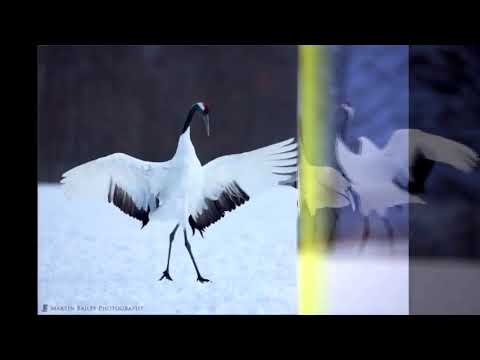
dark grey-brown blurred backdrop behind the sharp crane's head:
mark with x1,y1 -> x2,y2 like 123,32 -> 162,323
38,45 -> 297,182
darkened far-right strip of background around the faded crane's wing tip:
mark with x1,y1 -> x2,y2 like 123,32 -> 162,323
409,45 -> 480,315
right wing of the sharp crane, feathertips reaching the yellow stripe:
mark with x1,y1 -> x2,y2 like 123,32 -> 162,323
188,138 -> 297,236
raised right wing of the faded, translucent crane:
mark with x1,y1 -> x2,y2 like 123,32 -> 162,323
384,129 -> 479,180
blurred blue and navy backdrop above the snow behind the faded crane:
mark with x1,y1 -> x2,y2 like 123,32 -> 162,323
325,45 -> 480,259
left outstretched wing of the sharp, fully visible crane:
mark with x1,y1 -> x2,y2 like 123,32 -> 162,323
60,153 -> 168,228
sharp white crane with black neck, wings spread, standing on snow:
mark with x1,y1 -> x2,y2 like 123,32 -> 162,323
61,102 -> 297,283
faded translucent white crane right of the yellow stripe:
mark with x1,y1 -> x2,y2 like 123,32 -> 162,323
336,104 -> 480,244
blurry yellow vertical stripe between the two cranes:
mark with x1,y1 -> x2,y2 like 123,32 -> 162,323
298,45 -> 327,315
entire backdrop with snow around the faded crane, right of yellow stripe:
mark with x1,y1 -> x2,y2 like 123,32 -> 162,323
320,45 -> 480,314
